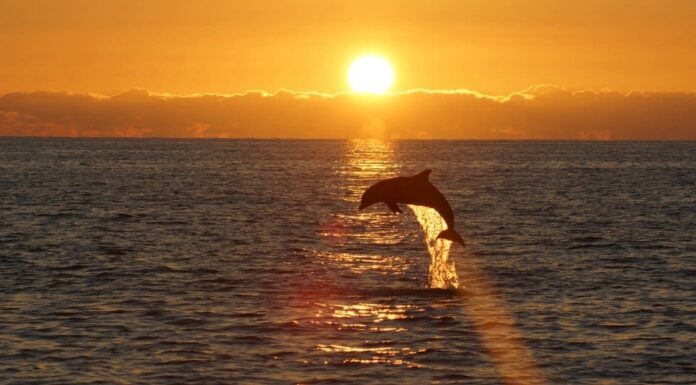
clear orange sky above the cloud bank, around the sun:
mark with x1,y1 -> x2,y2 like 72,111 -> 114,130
0,0 -> 696,95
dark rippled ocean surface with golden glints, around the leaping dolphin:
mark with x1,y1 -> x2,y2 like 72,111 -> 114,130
0,138 -> 696,385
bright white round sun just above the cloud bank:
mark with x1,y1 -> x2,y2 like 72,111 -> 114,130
348,56 -> 394,94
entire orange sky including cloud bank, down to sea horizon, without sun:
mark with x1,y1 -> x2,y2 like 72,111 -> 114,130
0,0 -> 696,139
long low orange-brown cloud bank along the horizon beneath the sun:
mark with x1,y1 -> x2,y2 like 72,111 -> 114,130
0,86 -> 696,140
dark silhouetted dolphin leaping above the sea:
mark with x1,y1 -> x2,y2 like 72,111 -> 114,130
358,170 -> 464,246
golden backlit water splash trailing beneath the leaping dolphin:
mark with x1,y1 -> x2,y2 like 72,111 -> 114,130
408,205 -> 459,289
